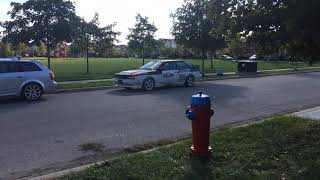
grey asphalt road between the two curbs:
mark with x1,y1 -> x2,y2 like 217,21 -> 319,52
0,73 -> 320,179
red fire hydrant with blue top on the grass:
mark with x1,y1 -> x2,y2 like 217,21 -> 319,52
186,92 -> 214,156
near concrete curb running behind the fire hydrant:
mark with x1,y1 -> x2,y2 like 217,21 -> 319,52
24,104 -> 319,180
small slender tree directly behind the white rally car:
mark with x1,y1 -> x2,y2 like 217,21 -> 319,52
127,14 -> 158,64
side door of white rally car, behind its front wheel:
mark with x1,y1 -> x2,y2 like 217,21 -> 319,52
161,62 -> 179,84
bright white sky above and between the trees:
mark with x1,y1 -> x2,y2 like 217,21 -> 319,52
0,0 -> 184,44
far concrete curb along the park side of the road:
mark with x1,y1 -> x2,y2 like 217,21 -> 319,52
52,70 -> 320,94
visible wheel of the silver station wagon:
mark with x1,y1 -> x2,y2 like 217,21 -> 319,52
22,83 -> 43,101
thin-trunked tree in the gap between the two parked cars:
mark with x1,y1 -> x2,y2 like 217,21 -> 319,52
73,13 -> 120,74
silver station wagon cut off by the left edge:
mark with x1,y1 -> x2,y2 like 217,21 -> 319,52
0,59 -> 57,101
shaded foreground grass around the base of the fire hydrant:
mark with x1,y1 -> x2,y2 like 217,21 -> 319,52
61,116 -> 320,180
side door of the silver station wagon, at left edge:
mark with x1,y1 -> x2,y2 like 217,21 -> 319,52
0,61 -> 24,95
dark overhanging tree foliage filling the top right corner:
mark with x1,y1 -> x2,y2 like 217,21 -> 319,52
209,0 -> 320,64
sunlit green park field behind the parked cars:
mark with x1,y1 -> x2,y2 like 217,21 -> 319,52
32,58 -> 319,81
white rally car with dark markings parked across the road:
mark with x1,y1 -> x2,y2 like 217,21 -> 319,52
113,60 -> 203,91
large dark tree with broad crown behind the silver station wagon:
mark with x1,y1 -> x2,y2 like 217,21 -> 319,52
2,0 -> 76,69
